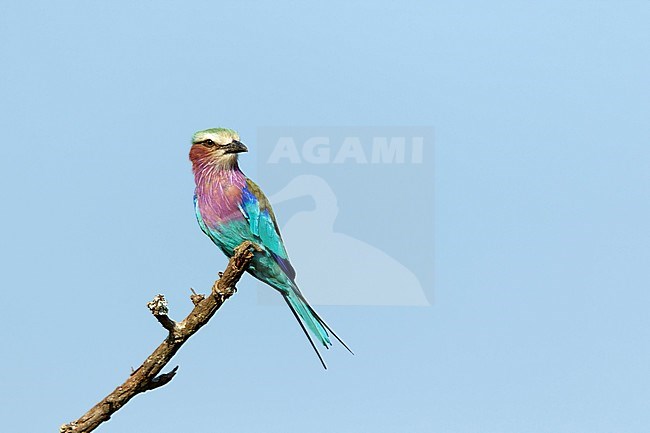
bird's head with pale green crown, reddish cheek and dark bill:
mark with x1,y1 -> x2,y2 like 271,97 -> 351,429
190,128 -> 248,169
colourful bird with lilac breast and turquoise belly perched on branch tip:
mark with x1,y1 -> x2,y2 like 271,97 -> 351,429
189,128 -> 353,369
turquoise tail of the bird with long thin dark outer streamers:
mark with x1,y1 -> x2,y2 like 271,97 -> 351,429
283,286 -> 353,369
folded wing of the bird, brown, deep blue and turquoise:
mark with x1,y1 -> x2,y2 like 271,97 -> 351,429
239,179 -> 296,280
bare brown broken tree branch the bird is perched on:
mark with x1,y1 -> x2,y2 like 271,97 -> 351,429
59,241 -> 255,433
